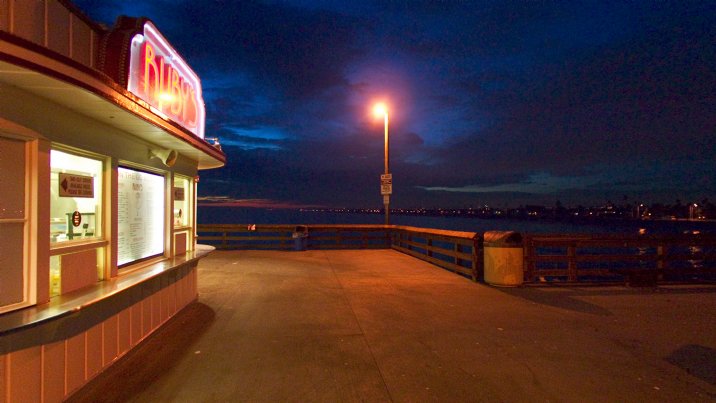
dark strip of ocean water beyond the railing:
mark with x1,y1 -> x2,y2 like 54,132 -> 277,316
197,206 -> 716,234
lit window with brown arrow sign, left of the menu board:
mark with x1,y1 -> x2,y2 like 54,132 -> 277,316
50,150 -> 102,242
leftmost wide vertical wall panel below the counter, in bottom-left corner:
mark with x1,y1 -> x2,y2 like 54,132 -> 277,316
8,346 -> 42,402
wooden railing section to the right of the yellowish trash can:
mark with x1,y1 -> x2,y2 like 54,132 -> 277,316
524,234 -> 716,284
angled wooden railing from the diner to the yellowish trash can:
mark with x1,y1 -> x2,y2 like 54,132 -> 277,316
197,224 -> 482,281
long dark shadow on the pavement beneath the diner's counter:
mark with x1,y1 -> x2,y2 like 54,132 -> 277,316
67,302 -> 216,402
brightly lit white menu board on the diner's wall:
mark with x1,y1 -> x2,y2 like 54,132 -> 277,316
117,168 -> 164,266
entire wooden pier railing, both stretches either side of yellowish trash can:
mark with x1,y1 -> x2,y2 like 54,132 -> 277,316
198,224 -> 716,284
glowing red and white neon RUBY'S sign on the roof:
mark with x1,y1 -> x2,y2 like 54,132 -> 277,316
127,22 -> 206,138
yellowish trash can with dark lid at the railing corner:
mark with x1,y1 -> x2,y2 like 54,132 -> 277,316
483,231 -> 524,287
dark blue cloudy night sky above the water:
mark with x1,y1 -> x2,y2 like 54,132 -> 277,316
75,0 -> 716,207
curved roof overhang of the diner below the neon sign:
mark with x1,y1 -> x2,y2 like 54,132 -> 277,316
0,31 -> 226,169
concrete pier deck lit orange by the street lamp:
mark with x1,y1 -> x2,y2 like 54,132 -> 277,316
71,250 -> 716,402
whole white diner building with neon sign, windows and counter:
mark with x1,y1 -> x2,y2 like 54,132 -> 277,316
0,0 -> 226,402
